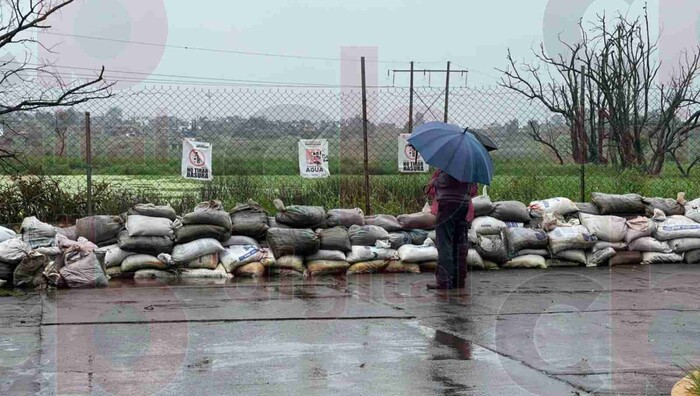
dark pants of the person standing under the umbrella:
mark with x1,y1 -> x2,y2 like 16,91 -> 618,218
435,201 -> 469,289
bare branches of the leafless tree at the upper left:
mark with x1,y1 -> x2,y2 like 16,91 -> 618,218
0,0 -> 114,169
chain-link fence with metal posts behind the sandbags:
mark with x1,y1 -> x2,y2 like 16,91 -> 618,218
0,87 -> 700,223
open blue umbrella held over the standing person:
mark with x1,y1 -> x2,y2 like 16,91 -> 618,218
408,122 -> 494,185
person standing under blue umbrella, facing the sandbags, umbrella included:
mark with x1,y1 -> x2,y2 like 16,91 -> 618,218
408,122 -> 497,290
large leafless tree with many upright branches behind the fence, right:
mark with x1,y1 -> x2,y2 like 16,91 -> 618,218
501,6 -> 700,174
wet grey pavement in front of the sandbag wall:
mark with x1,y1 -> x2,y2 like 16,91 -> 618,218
0,265 -> 700,395
